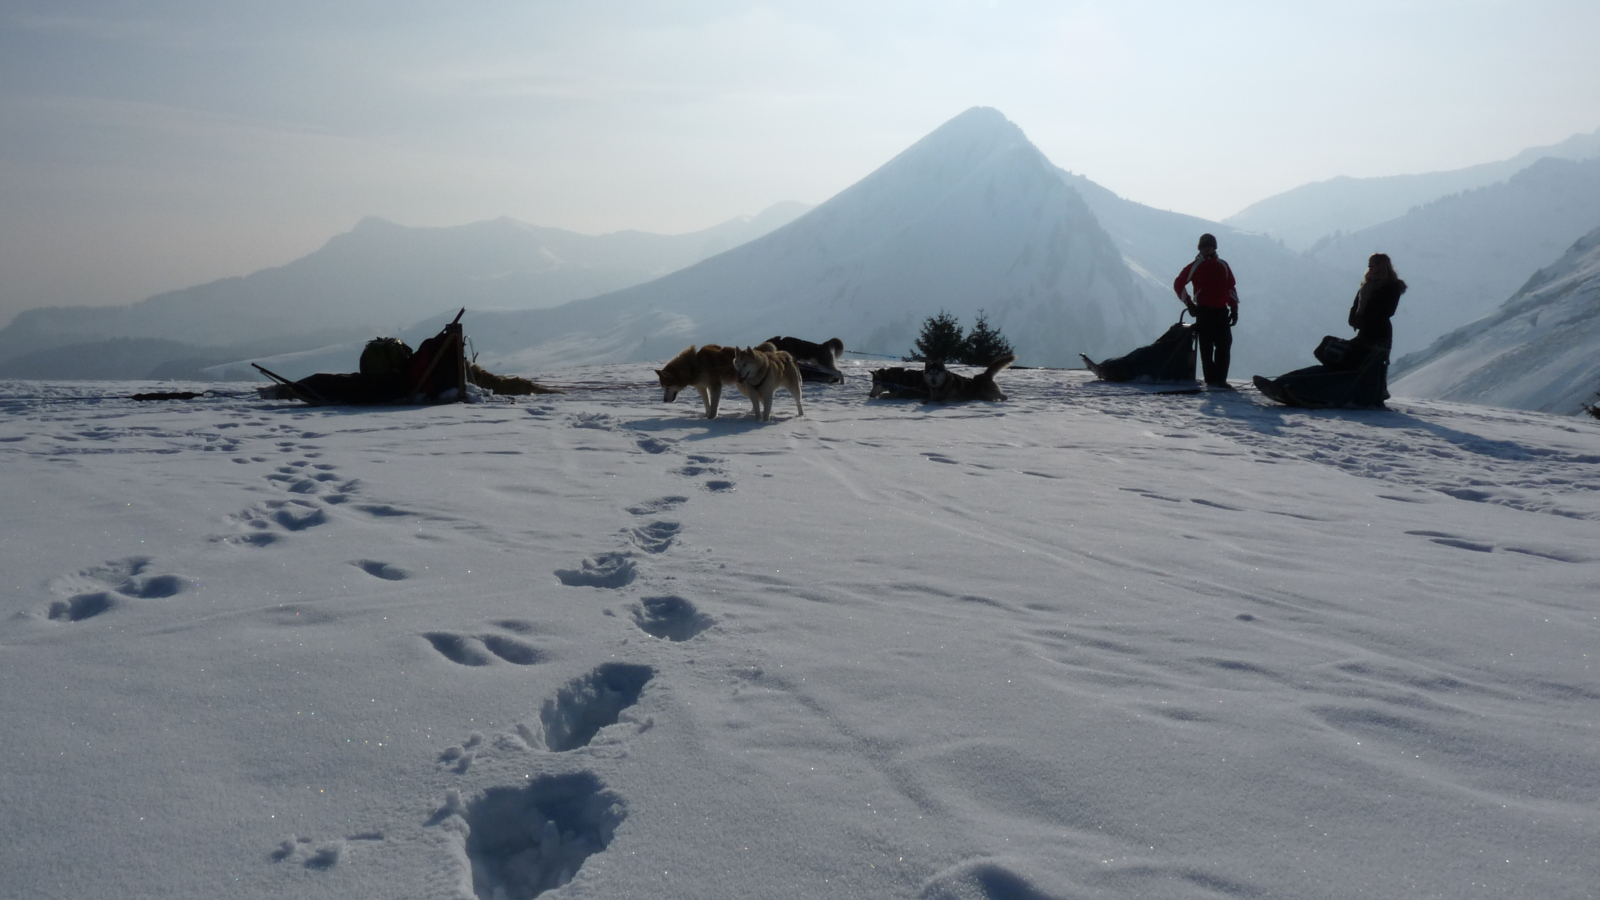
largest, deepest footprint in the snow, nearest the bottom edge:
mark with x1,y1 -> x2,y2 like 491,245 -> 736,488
457,772 -> 627,900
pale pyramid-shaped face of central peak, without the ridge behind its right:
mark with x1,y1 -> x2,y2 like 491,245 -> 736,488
432,107 -> 1166,370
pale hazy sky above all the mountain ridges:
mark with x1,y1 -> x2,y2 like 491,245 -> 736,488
0,0 -> 1600,322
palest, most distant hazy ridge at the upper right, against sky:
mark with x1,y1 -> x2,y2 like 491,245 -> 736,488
1222,128 -> 1600,250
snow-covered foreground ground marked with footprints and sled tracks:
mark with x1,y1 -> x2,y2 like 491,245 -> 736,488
0,364 -> 1600,900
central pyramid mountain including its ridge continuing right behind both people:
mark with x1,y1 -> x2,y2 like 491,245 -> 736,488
232,109 -> 1360,376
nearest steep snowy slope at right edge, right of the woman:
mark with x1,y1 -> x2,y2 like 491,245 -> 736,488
1394,227 -> 1600,413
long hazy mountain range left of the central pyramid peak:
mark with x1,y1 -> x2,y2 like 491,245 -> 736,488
0,202 -> 810,378
